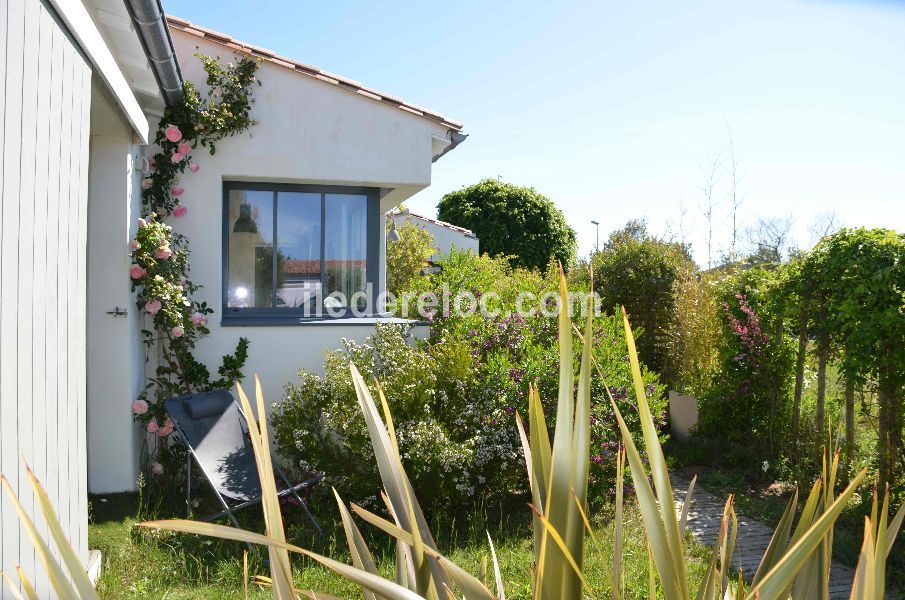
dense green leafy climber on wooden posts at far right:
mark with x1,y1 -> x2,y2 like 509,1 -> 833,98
783,228 -> 905,487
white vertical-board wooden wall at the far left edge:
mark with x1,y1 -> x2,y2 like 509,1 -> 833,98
0,0 -> 91,599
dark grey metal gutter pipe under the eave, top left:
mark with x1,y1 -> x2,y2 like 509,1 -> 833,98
125,0 -> 182,106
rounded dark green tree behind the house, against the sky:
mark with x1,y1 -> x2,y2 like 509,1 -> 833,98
437,179 -> 577,270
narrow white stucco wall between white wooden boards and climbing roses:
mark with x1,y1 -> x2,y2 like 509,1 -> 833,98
87,85 -> 145,494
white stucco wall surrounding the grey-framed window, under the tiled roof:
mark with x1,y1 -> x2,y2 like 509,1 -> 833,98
163,29 -> 447,404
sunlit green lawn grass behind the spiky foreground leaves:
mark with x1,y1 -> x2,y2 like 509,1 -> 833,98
88,494 -> 710,600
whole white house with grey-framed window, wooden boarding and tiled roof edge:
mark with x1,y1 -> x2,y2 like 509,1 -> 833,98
0,0 -> 464,598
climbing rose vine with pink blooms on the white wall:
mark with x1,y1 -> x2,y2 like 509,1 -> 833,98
129,54 -> 261,475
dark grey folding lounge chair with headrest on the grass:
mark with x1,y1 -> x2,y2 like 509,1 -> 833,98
164,390 -> 323,535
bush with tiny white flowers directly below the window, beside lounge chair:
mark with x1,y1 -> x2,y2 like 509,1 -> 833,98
272,324 -> 473,505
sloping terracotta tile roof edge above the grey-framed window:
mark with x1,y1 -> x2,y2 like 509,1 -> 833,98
167,15 -> 463,131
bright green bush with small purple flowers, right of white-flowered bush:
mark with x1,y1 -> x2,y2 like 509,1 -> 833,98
420,251 -> 666,500
